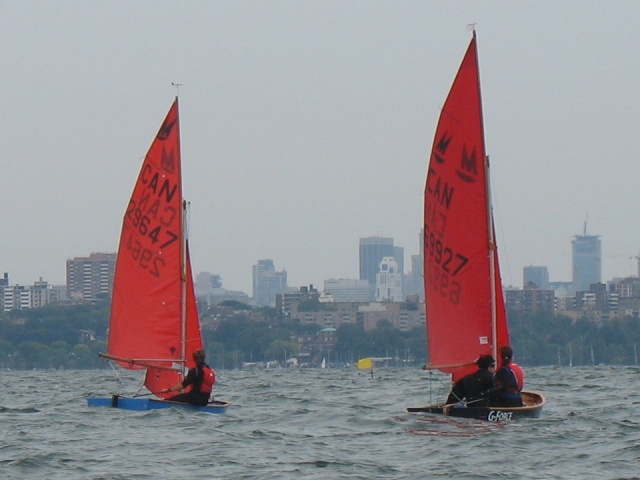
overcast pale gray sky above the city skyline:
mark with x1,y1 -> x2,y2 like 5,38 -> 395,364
0,0 -> 640,294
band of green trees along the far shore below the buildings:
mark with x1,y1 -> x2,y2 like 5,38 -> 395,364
0,302 -> 640,369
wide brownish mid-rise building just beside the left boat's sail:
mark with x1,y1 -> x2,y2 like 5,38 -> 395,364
67,253 -> 116,302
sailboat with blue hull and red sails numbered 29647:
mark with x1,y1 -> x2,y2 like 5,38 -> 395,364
88,97 -> 229,413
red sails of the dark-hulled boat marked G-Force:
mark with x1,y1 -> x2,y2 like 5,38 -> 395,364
424,32 -> 509,376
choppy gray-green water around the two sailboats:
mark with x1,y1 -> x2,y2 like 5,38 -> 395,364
0,366 -> 640,479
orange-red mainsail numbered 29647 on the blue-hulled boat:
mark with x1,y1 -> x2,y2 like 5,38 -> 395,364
108,99 -> 195,372
